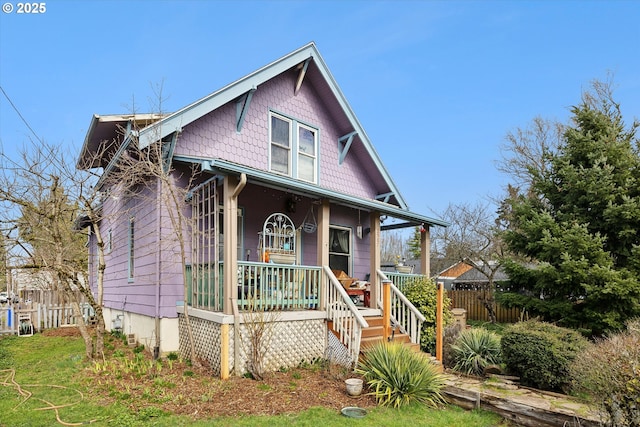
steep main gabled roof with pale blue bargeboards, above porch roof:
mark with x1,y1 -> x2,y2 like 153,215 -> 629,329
78,42 -> 448,226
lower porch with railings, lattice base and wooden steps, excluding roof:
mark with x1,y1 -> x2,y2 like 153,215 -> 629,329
178,261 -> 425,378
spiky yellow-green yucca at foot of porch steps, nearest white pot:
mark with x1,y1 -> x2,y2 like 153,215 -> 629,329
356,341 -> 444,408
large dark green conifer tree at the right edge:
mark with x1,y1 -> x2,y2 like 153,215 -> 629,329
501,82 -> 640,334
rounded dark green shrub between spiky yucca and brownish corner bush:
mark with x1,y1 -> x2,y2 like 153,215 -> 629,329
502,320 -> 588,391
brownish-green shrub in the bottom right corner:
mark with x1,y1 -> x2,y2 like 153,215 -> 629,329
569,319 -> 640,427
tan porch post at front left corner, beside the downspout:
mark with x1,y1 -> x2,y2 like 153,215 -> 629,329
222,175 -> 238,314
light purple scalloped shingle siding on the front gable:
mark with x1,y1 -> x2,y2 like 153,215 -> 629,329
175,71 -> 383,199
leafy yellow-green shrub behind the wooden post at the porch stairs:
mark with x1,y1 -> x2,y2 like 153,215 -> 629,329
403,277 -> 453,354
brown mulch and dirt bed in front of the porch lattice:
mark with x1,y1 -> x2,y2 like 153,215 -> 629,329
79,331 -> 376,419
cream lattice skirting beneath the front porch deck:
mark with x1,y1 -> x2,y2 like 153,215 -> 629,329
179,314 -> 328,375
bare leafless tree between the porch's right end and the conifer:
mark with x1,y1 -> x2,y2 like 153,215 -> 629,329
432,203 -> 504,322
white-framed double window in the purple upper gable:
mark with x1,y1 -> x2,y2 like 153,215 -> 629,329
269,113 -> 318,183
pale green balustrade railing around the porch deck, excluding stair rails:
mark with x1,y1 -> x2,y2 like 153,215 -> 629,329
186,261 -> 322,311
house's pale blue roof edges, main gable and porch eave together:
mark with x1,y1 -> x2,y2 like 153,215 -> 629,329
78,42 -> 448,231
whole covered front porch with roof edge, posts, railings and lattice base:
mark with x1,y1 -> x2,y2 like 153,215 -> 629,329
178,164 -> 445,378
